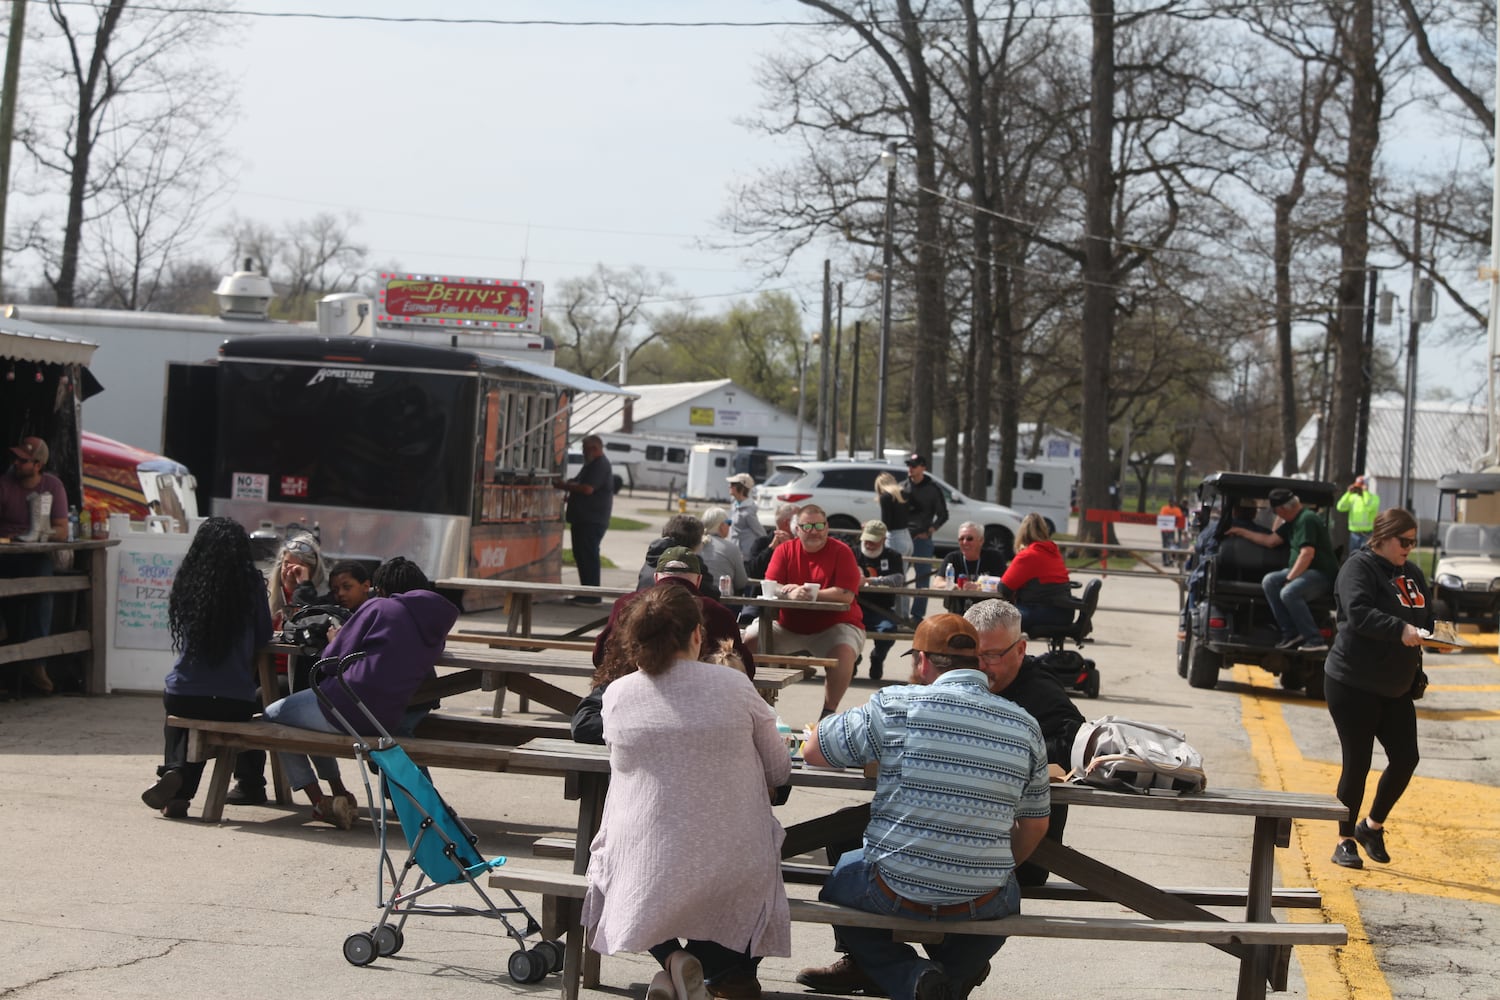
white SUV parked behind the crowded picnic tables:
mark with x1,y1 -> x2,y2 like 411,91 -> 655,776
755,462 -> 1022,553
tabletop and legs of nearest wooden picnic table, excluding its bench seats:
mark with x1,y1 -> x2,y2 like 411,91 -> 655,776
510,739 -> 1349,1000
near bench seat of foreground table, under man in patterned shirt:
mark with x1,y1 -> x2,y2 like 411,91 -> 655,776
489,865 -> 1349,1000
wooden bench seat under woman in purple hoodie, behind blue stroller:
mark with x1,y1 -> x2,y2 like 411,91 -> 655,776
167,714 -> 567,823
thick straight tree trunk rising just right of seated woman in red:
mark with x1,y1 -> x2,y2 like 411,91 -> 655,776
1079,0 -> 1115,540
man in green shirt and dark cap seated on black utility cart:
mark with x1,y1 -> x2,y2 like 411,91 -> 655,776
1226,489 -> 1338,652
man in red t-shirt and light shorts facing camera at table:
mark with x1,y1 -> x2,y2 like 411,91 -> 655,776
765,504 -> 864,715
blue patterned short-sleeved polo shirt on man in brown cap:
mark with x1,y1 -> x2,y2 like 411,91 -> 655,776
818,670 -> 1052,904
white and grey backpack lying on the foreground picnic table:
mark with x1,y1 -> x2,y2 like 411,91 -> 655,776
1070,715 -> 1208,795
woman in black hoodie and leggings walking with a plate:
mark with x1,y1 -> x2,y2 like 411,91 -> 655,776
1323,507 -> 1433,868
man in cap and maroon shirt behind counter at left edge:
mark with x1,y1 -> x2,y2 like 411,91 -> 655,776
0,438 -> 68,694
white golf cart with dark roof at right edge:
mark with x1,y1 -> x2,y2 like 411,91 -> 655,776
1428,472 -> 1500,625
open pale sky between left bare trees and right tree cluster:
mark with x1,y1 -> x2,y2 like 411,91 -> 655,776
202,0 -> 834,325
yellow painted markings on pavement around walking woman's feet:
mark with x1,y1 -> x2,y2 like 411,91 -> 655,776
1233,664 -> 1500,1000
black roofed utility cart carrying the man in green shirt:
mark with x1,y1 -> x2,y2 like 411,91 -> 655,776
1178,472 -> 1341,699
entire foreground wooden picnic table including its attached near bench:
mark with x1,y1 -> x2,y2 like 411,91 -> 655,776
492,738 -> 1349,1000
